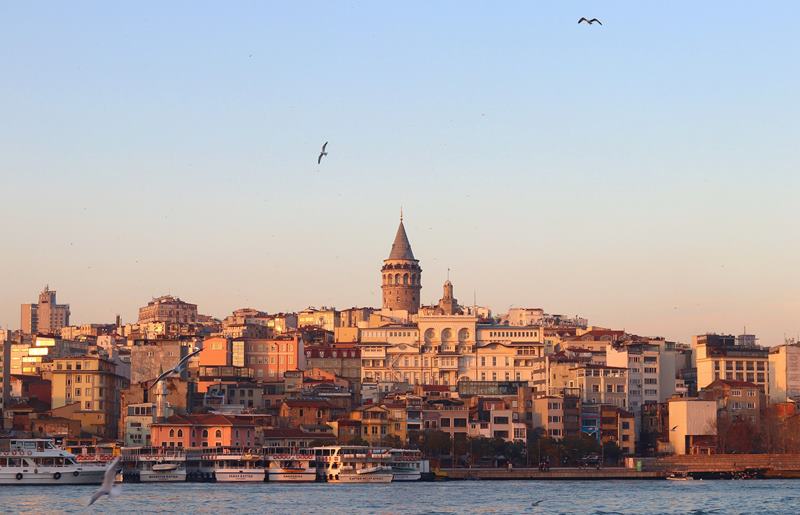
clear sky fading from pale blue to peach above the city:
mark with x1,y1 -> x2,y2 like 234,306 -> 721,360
0,1 -> 800,345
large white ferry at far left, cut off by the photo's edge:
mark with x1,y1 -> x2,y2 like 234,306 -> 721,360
0,439 -> 105,485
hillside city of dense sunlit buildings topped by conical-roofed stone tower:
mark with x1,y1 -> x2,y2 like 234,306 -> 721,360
0,217 -> 800,470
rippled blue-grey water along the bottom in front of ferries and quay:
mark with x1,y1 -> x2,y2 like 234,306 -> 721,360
0,480 -> 800,515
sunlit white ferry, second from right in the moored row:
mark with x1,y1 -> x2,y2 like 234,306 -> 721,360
312,445 -> 394,483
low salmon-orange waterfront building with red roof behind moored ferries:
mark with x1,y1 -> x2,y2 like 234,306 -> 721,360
150,415 -> 256,447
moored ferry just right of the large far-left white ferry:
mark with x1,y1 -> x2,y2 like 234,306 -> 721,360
122,447 -> 187,483
